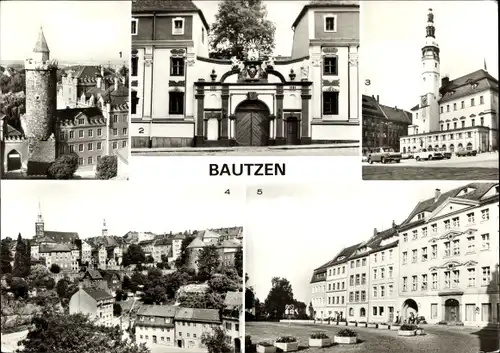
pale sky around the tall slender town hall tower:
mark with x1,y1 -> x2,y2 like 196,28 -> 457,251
360,1 -> 498,110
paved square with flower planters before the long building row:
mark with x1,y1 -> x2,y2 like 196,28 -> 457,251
245,322 -> 499,353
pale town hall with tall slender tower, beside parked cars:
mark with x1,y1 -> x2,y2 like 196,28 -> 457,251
400,10 -> 498,152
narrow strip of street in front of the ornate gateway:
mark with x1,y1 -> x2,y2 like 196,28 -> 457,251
132,143 -> 360,156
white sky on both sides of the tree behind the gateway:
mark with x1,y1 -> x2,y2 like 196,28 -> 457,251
193,0 -> 310,56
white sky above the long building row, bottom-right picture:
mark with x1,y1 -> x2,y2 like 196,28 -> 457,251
245,181 -> 472,304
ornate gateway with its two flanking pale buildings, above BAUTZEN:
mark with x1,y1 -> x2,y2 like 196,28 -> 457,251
131,0 -> 361,149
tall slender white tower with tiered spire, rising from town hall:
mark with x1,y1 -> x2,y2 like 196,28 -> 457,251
416,9 -> 441,134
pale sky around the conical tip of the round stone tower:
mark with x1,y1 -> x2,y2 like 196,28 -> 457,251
0,0 -> 131,62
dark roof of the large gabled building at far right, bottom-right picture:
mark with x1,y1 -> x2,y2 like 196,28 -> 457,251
401,183 -> 498,226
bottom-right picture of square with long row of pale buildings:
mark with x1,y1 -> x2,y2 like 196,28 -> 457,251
245,181 -> 500,353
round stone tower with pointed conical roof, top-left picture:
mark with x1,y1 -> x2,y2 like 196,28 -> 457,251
21,27 -> 57,174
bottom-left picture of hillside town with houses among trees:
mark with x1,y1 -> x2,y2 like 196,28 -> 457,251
1,180 -> 245,353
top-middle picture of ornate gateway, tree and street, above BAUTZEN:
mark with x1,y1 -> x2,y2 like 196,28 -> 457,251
131,0 -> 361,158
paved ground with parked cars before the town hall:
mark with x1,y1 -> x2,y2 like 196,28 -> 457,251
363,153 -> 499,180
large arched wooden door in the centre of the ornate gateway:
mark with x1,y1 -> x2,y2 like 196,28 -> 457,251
235,100 -> 269,146
